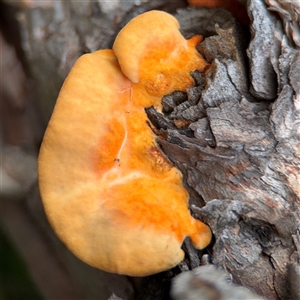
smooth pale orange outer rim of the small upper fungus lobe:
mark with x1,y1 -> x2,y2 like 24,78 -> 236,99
113,10 -> 179,83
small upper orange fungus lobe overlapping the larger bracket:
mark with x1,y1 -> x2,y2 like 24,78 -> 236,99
113,10 -> 208,107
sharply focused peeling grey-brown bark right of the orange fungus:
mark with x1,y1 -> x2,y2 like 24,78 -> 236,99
146,1 -> 300,299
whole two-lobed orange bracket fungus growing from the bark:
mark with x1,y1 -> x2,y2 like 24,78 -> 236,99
38,11 -> 211,276
